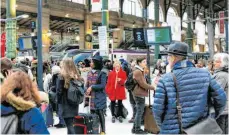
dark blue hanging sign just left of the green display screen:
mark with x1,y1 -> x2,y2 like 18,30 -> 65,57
133,28 -> 145,46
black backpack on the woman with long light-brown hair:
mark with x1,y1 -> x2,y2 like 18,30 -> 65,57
67,80 -> 84,105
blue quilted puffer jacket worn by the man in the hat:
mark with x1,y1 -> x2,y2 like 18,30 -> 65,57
153,60 -> 226,134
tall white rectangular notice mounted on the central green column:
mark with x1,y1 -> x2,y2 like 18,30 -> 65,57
98,26 -> 109,56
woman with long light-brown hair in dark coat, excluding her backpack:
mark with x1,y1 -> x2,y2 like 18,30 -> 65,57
57,58 -> 83,134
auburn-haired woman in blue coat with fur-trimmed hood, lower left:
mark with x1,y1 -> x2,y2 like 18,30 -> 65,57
1,71 -> 49,134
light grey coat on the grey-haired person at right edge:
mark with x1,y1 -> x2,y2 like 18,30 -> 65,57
213,67 -> 228,114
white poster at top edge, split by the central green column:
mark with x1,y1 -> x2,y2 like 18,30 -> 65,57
91,0 -> 119,12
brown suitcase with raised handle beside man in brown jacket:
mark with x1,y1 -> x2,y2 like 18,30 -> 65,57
144,91 -> 160,134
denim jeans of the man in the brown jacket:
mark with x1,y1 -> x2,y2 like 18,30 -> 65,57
134,97 -> 145,128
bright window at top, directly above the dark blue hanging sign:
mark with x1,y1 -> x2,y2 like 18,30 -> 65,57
123,0 -> 142,17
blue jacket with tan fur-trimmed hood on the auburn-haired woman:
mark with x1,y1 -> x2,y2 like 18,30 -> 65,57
1,92 -> 49,134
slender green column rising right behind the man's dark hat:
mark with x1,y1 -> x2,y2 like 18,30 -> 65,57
186,0 -> 193,53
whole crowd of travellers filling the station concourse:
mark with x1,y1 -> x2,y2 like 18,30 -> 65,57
0,42 -> 229,134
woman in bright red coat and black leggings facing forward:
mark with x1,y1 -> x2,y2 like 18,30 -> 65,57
106,61 -> 126,123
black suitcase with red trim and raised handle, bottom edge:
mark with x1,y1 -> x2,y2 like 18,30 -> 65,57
73,97 -> 99,134
